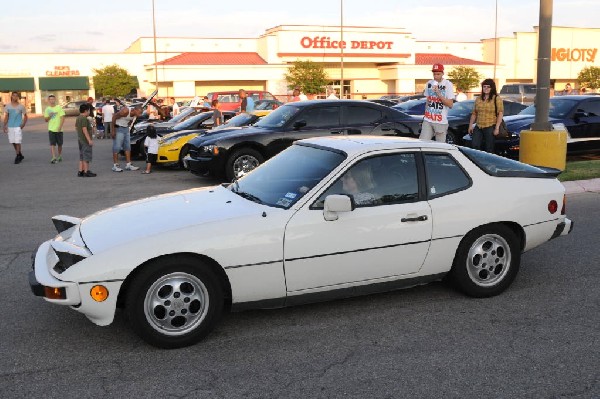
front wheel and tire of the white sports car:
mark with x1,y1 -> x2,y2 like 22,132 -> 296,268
125,255 -> 224,349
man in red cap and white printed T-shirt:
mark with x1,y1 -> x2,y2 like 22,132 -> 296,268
419,64 -> 454,143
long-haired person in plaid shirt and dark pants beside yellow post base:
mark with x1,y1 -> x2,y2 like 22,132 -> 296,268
468,79 -> 504,153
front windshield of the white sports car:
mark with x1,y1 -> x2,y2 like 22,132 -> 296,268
229,144 -> 346,209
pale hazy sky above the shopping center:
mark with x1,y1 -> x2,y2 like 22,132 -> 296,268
0,0 -> 600,53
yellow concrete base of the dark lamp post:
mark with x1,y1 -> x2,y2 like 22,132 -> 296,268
519,130 -> 567,170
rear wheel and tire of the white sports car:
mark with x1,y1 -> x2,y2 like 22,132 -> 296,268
449,224 -> 521,298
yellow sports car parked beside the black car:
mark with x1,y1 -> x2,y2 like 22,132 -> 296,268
156,111 -> 270,167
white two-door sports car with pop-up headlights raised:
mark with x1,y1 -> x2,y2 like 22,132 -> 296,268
29,136 -> 573,348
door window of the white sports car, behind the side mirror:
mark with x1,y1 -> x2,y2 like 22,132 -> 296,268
312,153 -> 419,209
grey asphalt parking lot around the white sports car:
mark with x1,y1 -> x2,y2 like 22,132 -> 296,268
0,118 -> 600,399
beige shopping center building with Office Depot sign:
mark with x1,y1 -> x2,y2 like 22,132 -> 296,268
0,25 -> 600,113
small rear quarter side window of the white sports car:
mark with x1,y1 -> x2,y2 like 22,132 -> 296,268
424,153 -> 471,199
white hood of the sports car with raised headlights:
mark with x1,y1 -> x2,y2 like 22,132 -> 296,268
79,186 -> 265,254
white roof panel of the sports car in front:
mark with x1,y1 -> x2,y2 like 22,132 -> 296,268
296,135 -> 456,155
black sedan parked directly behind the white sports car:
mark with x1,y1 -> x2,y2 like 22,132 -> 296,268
183,100 -> 421,180
